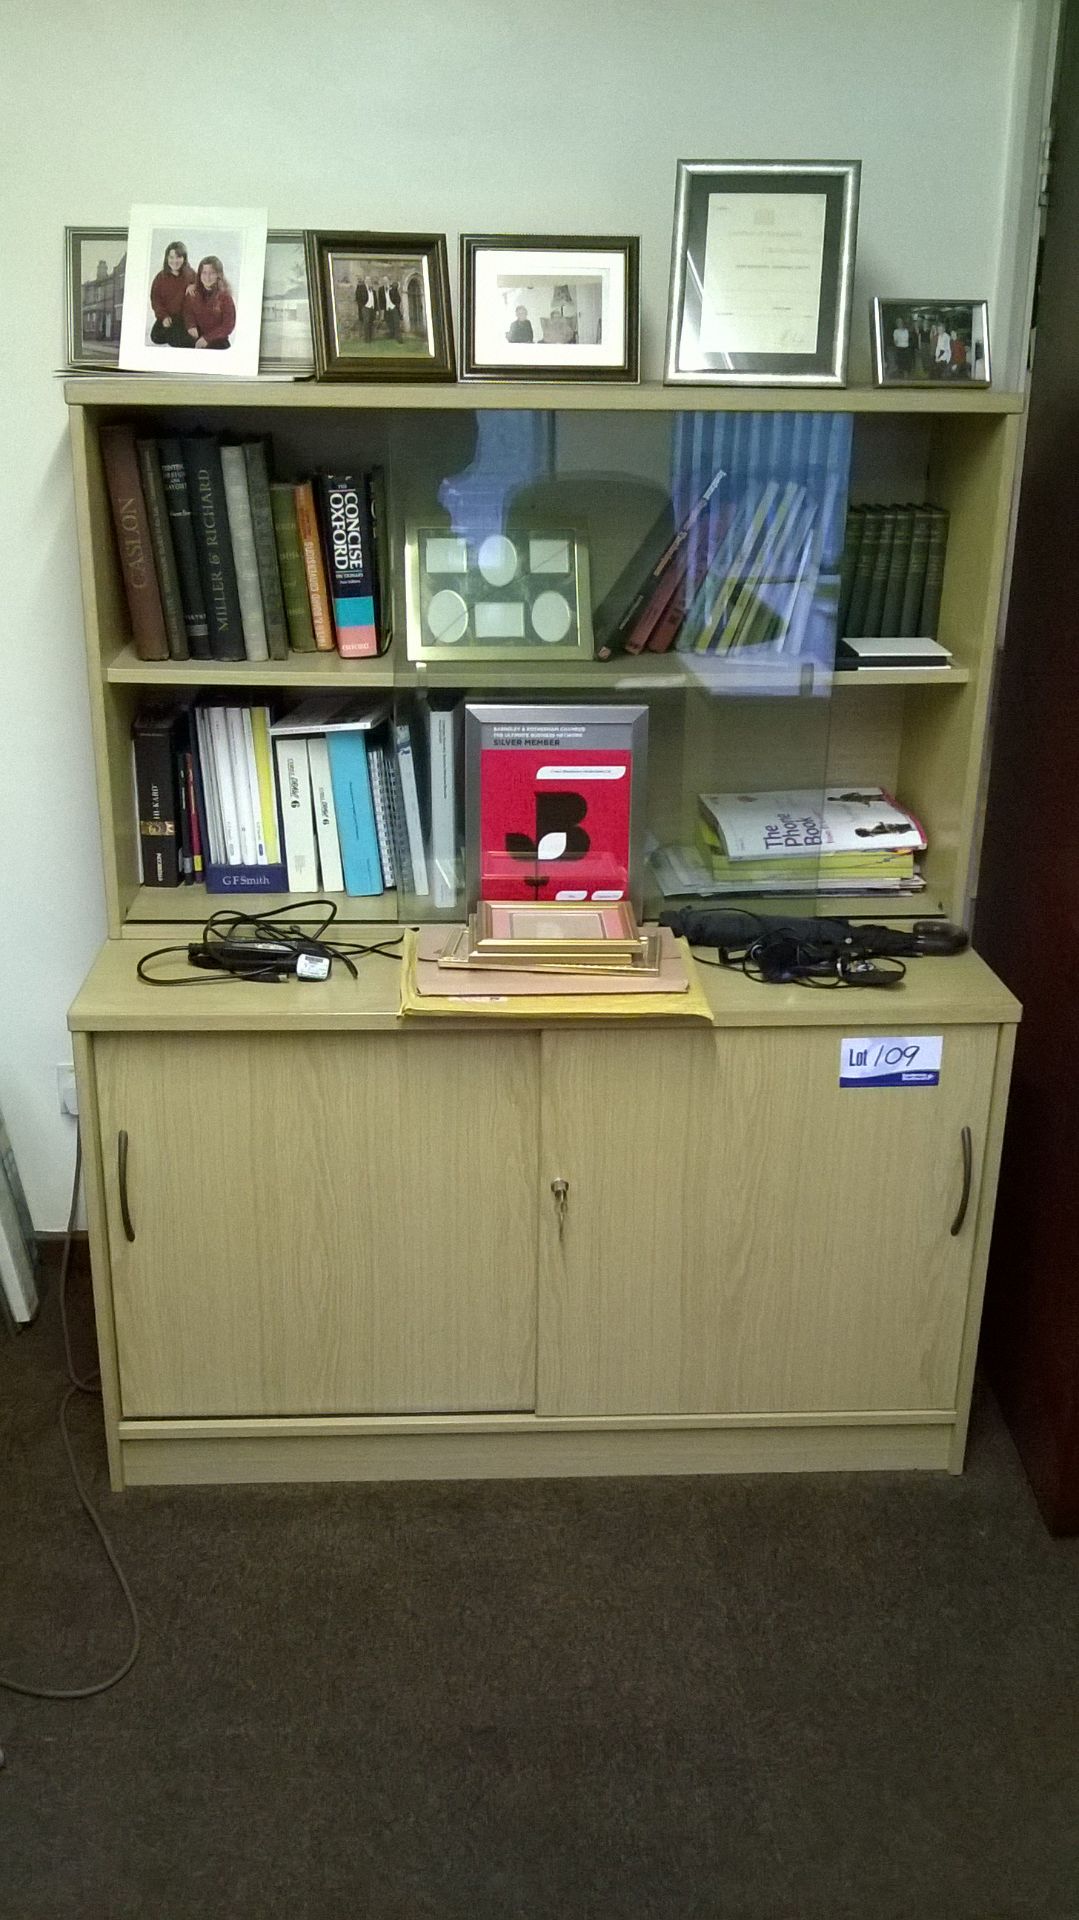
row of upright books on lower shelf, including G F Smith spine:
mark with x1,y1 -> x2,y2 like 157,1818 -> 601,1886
132,695 -> 461,908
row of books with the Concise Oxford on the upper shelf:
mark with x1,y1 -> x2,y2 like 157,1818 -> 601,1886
102,424 -> 390,660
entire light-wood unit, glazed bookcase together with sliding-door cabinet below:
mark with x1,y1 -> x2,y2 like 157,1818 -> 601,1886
67,376 -> 1021,1488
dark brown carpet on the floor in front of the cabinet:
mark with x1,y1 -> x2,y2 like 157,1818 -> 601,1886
0,1259 -> 1079,1920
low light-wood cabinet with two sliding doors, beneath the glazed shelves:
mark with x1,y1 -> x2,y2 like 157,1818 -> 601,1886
71,941 -> 1018,1486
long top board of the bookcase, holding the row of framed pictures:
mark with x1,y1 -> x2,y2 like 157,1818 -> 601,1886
63,372 -> 1023,415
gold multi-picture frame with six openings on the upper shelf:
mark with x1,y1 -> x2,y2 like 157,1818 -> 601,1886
405,524 -> 593,662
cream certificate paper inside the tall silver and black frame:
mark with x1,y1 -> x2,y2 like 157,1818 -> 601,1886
699,192 -> 827,353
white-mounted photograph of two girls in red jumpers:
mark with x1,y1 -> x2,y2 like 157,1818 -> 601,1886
119,205 -> 267,378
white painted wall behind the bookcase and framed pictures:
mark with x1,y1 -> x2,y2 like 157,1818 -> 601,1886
0,0 -> 1054,1229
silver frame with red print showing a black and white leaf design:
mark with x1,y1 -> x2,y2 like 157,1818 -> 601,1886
456,701 -> 649,918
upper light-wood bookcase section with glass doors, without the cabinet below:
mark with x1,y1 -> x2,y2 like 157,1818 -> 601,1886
67,376 -> 1021,937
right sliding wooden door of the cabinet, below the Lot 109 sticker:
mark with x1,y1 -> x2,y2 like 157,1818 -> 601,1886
538,1027 -> 996,1415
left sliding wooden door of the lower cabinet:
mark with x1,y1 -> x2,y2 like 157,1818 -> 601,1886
94,1033 -> 538,1417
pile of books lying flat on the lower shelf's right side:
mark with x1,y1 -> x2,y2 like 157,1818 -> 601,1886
697,787 -> 925,897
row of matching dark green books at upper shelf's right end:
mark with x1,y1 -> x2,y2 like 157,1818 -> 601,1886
839,505 -> 948,639
